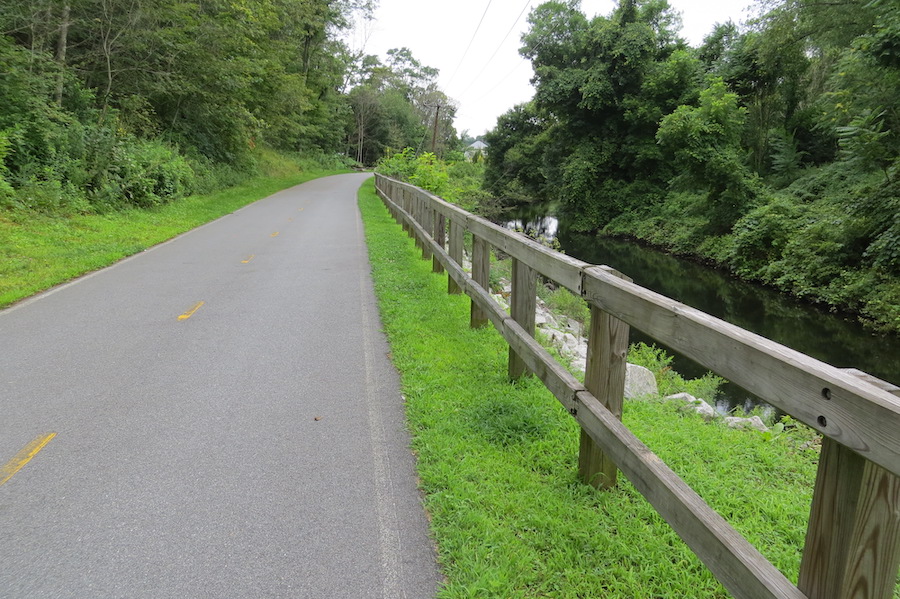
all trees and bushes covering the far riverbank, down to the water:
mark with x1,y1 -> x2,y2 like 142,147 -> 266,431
485,0 -> 900,333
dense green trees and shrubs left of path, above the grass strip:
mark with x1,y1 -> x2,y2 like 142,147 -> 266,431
0,0 -> 398,211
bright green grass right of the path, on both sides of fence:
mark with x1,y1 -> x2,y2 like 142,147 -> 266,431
360,183 -> 880,599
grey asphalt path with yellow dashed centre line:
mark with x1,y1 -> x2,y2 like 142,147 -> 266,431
0,175 -> 439,599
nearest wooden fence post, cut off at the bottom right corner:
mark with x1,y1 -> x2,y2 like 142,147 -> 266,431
797,371 -> 900,599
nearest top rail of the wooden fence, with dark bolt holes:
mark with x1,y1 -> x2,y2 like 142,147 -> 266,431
584,267 -> 900,475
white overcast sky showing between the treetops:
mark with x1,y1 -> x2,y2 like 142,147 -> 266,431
348,0 -> 752,136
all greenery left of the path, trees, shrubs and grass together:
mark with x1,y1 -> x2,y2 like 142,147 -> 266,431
0,0 -> 458,306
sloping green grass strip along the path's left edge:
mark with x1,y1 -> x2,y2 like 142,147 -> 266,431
0,171 -> 346,308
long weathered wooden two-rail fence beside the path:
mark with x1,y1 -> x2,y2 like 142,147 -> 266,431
376,175 -> 900,599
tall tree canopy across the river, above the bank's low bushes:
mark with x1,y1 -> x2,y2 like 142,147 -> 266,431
486,0 -> 900,232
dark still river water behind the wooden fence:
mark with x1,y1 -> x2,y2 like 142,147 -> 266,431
503,211 -> 900,412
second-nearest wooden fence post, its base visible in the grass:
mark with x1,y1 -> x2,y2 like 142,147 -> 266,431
578,266 -> 631,489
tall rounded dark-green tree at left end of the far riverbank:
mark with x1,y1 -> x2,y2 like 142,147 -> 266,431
500,0 -> 700,230
